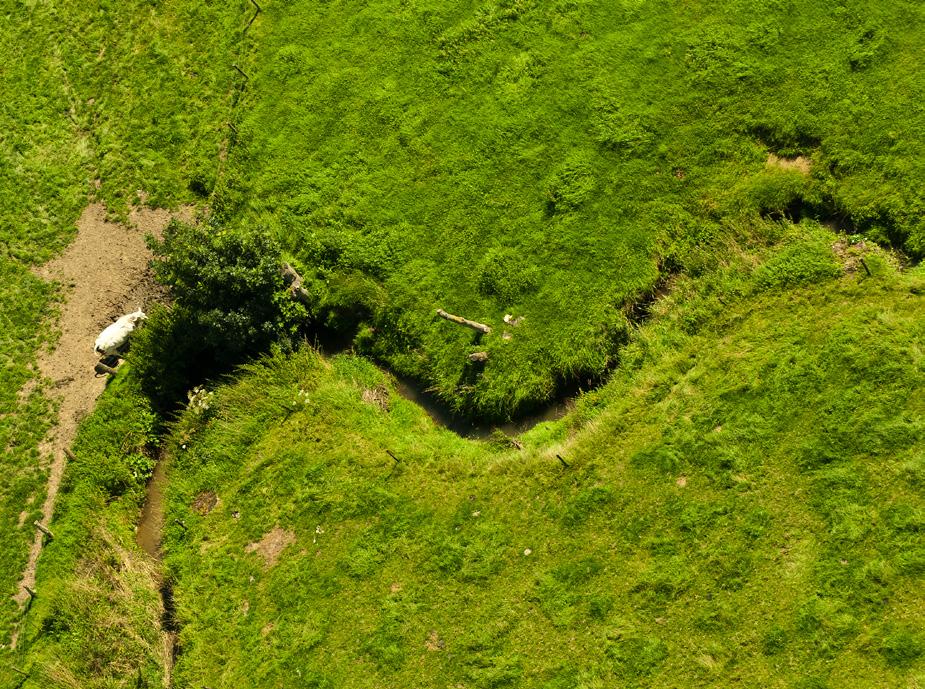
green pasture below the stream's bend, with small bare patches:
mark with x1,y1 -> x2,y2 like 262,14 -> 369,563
130,226 -> 925,688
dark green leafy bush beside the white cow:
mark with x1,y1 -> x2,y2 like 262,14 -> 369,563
132,222 -> 305,408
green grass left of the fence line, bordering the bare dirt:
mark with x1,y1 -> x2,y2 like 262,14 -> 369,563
0,2 -> 248,656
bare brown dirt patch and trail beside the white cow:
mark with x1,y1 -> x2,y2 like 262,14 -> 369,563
13,203 -> 193,620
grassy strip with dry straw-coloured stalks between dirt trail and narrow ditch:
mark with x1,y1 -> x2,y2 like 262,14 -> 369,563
9,373 -> 169,687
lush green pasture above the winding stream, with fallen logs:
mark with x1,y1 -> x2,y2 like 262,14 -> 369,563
216,0 -> 925,416
